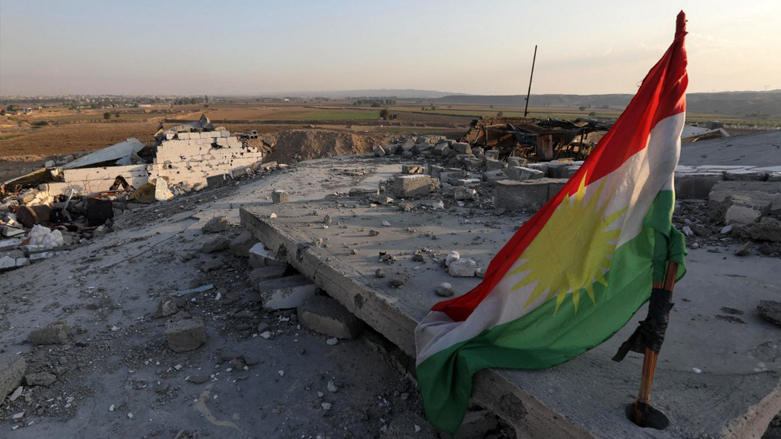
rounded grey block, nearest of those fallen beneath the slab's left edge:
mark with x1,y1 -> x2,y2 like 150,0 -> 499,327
297,296 -> 364,339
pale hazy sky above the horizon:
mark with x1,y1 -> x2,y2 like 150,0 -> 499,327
0,0 -> 781,96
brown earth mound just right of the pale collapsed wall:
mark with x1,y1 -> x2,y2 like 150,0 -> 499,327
262,129 -> 382,163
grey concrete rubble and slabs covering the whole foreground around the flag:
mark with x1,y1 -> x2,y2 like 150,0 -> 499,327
0,124 -> 781,439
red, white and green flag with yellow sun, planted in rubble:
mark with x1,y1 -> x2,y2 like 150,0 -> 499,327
415,12 -> 688,434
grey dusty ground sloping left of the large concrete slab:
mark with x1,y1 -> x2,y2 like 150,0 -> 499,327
0,160 -> 516,438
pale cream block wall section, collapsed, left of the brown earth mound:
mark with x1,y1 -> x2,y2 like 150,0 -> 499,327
149,131 -> 263,184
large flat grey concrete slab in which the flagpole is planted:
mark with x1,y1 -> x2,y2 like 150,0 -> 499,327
241,200 -> 781,439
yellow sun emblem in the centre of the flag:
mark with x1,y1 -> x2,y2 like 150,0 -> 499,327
508,176 -> 626,314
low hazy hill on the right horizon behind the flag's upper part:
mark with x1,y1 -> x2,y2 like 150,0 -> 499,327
436,90 -> 781,117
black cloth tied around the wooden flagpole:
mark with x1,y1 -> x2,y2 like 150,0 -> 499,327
613,288 -> 673,361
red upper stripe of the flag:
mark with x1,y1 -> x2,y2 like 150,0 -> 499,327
431,11 -> 689,321
